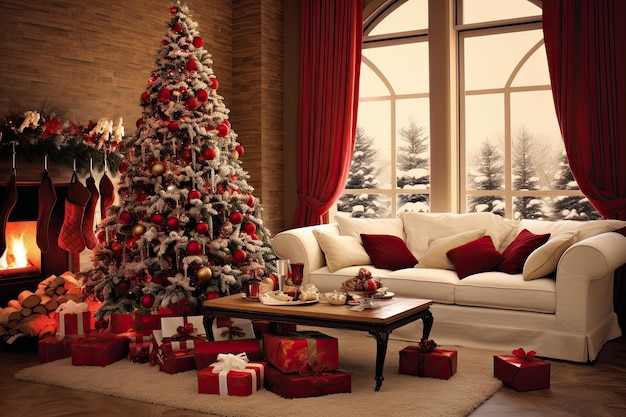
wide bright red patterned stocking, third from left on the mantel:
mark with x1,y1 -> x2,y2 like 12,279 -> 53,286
59,173 -> 91,253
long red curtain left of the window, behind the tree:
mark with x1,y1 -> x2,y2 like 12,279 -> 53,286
294,0 -> 363,227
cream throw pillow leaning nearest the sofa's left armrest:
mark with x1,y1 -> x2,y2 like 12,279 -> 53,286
313,229 -> 372,272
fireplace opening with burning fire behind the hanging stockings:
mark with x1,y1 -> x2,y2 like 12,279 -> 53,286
0,181 -> 73,306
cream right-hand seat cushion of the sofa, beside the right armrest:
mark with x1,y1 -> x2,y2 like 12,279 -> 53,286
450,271 -> 556,314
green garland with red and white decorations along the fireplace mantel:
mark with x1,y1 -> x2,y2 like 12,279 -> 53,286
0,110 -> 124,177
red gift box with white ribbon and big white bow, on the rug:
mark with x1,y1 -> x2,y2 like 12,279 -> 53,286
198,356 -> 265,397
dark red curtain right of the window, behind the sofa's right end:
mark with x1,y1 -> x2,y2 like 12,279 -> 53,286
542,0 -> 626,329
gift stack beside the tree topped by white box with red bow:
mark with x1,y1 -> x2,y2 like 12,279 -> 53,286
150,316 -> 206,374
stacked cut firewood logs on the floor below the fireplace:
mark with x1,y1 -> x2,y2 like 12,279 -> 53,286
0,271 -> 83,341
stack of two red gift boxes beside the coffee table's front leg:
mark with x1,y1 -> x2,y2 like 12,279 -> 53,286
263,331 -> 352,398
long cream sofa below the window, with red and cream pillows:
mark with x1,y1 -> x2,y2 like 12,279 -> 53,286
273,213 -> 626,362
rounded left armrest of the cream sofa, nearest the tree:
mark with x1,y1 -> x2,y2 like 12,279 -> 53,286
272,223 -> 340,283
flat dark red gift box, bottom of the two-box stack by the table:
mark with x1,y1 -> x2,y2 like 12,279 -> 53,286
265,365 -> 352,398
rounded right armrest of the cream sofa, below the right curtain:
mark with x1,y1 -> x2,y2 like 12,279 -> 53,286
556,232 -> 626,332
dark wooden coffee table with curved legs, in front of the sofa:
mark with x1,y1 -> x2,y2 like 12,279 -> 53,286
202,294 -> 433,391
